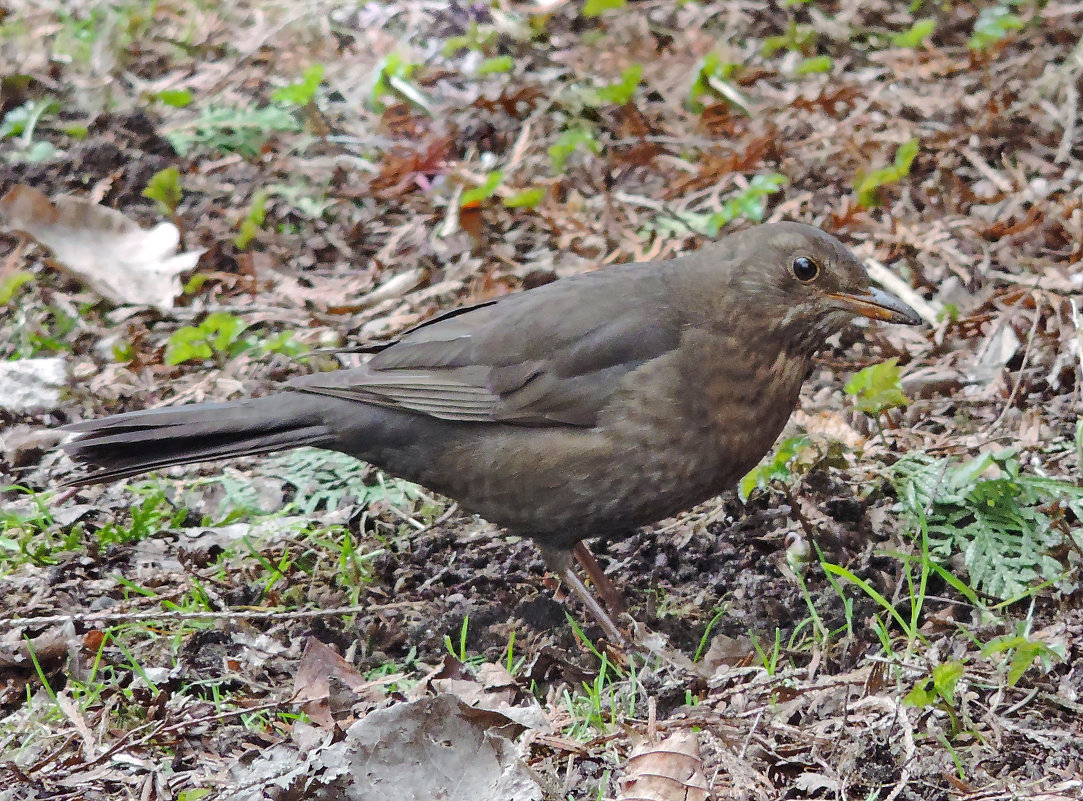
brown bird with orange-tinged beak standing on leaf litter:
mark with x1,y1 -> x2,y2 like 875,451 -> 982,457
64,223 -> 919,638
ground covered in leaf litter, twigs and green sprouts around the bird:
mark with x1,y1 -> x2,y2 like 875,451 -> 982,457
0,0 -> 1083,799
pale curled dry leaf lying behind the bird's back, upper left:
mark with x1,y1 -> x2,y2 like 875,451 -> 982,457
0,184 -> 204,312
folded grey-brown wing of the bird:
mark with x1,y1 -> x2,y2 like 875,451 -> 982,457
290,264 -> 680,426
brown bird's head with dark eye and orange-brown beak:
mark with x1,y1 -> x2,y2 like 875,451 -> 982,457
727,223 -> 921,351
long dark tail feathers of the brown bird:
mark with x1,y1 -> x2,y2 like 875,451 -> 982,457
63,392 -> 335,485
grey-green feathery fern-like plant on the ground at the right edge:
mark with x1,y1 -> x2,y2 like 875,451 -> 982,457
890,450 -> 1083,599
